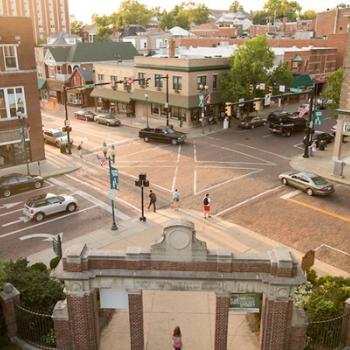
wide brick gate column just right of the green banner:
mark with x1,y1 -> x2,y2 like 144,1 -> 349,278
260,297 -> 293,350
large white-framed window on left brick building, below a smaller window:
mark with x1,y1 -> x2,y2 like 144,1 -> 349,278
0,87 -> 27,120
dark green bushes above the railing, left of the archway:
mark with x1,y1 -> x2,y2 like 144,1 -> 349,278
4,258 -> 64,313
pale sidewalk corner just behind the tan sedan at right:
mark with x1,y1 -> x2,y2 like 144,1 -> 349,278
290,144 -> 350,185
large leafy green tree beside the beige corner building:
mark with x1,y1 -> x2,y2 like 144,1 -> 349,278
221,35 -> 274,101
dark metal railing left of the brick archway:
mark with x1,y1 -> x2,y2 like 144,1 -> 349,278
16,305 -> 56,350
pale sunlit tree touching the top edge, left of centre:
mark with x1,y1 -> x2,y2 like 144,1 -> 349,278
118,0 -> 152,26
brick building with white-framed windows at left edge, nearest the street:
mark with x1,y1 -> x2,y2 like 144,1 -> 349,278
0,17 -> 45,167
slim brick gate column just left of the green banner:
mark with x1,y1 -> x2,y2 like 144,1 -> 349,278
215,294 -> 230,350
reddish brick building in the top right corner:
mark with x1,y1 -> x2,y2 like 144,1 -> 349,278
315,7 -> 350,36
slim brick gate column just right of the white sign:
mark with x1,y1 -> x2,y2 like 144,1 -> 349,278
128,291 -> 144,350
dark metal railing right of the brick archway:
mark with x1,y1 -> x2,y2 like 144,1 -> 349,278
305,312 -> 350,350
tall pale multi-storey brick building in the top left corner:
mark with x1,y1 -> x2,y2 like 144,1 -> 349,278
0,0 -> 70,42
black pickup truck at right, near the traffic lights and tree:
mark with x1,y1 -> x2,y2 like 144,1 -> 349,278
269,114 -> 307,136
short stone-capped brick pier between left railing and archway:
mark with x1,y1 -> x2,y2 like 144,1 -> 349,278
52,300 -> 73,350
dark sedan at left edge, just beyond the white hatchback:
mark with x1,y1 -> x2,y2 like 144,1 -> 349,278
0,173 -> 44,197
